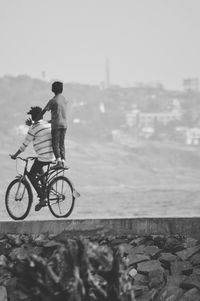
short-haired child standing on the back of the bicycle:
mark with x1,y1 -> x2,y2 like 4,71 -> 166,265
38,81 -> 67,167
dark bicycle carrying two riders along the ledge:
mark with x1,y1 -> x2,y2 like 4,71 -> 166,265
5,156 -> 75,220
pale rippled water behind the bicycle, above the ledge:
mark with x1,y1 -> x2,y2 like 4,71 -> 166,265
0,143 -> 200,220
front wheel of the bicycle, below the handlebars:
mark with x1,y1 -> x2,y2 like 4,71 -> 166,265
5,179 -> 33,220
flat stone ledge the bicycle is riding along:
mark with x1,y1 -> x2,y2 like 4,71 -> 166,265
0,217 -> 200,238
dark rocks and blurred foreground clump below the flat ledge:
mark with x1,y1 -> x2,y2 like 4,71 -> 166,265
0,232 -> 200,301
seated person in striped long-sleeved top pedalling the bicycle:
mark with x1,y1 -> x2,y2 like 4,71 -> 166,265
11,107 -> 54,211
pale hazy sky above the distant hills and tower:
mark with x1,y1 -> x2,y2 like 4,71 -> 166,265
0,0 -> 200,89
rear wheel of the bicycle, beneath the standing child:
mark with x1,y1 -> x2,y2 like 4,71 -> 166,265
48,176 -> 75,218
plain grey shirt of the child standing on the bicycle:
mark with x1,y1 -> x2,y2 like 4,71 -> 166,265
45,94 -> 67,129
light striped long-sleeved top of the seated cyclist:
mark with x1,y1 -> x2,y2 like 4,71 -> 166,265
19,120 -> 54,162
